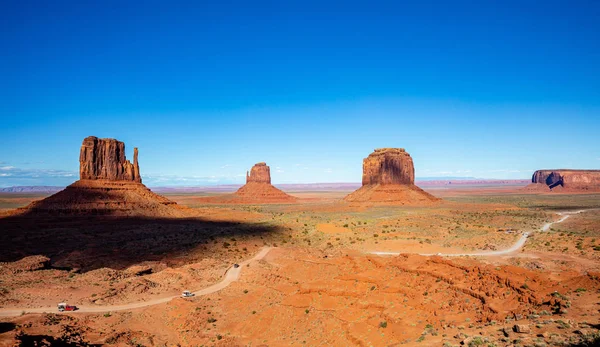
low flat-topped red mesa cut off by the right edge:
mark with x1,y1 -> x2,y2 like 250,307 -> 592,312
525,169 -> 600,191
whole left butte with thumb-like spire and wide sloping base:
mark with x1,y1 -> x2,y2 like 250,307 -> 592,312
15,136 -> 188,217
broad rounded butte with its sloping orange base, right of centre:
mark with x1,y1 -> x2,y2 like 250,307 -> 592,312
344,148 -> 439,205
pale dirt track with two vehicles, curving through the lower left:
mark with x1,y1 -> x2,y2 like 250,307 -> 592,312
0,247 -> 272,317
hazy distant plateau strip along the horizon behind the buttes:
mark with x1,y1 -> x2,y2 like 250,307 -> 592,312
0,181 -> 531,194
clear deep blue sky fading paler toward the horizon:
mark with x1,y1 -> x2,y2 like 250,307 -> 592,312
0,1 -> 600,186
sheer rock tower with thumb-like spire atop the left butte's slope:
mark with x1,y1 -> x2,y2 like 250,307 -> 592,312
79,136 -> 142,183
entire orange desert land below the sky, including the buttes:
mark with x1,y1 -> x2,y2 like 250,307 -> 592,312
0,137 -> 600,346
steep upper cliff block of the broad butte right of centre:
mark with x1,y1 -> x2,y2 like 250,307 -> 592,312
362,148 -> 415,186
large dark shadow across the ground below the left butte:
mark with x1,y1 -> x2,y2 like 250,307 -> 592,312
0,214 -> 280,271
